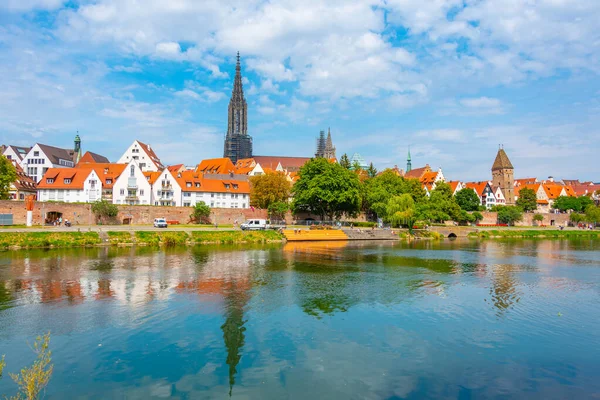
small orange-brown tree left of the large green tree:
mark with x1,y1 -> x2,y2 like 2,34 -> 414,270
250,172 -> 291,209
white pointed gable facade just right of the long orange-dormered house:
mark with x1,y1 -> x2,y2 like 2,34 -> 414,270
112,159 -> 153,205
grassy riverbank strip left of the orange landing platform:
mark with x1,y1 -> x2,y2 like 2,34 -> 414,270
0,230 -> 284,250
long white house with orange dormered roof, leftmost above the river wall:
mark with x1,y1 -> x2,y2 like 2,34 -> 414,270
37,168 -> 102,203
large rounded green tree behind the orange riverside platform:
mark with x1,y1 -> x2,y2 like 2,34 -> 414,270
292,158 -> 360,219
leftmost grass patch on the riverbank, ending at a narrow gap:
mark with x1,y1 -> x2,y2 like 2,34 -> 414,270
0,232 -> 102,250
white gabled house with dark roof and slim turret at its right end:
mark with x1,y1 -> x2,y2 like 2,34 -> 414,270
21,140 -> 81,182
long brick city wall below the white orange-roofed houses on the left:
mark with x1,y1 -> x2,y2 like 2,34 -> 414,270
0,201 -> 267,225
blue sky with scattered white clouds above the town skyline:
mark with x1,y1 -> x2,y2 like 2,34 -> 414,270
0,0 -> 600,181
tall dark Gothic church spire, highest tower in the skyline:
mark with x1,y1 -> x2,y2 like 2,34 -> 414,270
223,52 -> 252,164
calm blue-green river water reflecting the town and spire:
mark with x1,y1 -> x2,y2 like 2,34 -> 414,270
0,240 -> 600,399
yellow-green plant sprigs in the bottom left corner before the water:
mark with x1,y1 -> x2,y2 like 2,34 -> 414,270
0,332 -> 54,400
